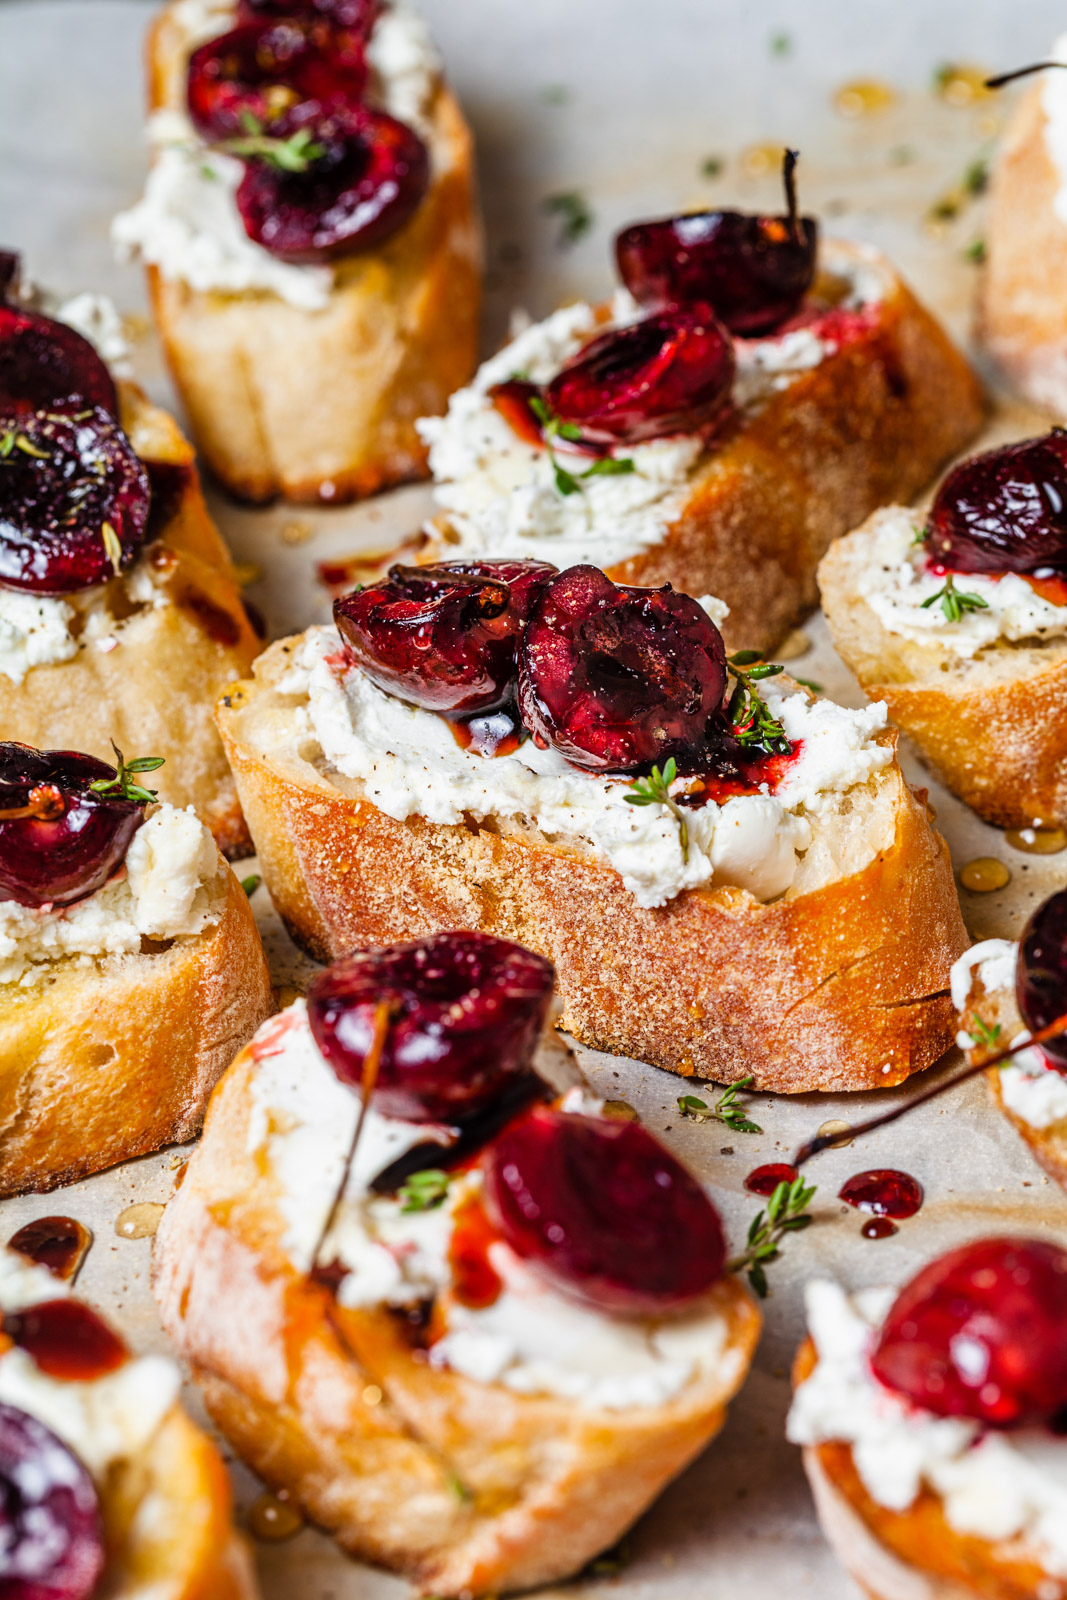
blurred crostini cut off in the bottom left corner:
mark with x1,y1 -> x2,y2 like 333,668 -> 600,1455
0,1250 -> 258,1600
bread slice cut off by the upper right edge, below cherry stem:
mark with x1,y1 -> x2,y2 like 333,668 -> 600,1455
979,82 -> 1067,419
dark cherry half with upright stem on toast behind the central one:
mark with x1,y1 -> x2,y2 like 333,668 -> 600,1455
614,211 -> 819,338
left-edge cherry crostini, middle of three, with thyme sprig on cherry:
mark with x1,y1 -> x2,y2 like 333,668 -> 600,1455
0,744 -> 272,1195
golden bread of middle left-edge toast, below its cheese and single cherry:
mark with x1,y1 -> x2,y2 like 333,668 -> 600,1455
0,862 -> 274,1195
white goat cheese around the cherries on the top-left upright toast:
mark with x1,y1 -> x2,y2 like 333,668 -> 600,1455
112,0 -> 445,312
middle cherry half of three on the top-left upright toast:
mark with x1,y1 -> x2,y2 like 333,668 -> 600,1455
186,18 -> 366,139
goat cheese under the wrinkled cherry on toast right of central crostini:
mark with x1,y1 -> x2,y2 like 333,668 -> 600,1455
856,506 -> 1067,661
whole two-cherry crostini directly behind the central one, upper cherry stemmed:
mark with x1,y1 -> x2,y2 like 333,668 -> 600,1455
419,167 -> 982,650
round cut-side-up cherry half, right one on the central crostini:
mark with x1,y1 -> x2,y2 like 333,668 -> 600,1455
518,566 -> 726,773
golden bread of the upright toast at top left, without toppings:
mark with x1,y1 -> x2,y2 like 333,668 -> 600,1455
140,0 -> 482,504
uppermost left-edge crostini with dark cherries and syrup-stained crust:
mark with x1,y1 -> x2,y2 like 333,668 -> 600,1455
0,256 -> 259,854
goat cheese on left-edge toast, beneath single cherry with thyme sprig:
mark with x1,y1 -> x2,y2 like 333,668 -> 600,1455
0,805 -> 229,984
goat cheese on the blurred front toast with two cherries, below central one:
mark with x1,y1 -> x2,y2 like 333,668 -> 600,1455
246,1000 -> 741,1410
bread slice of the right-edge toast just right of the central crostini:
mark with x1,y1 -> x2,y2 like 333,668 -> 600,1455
819,512 -> 1067,827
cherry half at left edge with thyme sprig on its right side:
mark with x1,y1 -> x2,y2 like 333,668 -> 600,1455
0,742 -> 144,906
